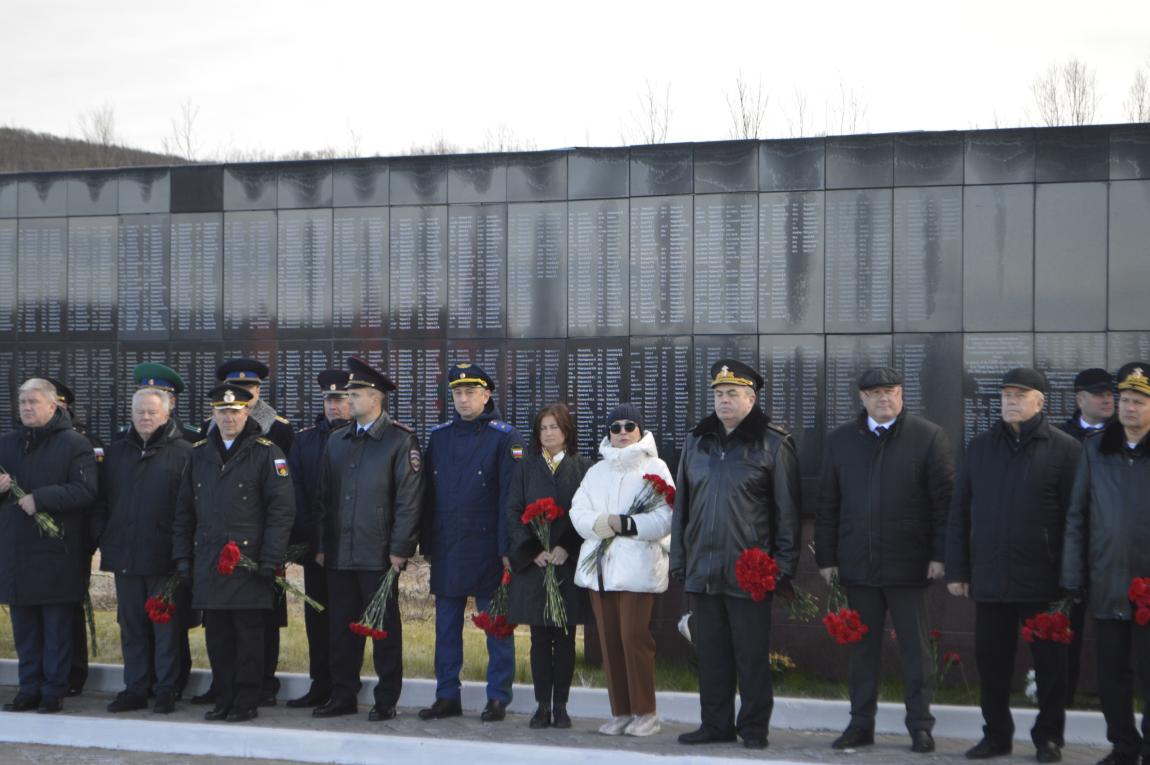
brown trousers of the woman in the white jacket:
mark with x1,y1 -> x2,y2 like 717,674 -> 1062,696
591,590 -> 656,717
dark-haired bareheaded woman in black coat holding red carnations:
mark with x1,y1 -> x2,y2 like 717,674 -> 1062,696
507,404 -> 591,728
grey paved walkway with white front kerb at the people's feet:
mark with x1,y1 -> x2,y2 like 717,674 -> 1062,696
0,687 -> 1106,765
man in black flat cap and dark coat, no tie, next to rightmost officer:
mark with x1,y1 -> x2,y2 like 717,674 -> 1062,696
946,368 -> 1081,763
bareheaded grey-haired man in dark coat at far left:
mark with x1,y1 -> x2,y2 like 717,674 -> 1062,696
0,377 -> 98,713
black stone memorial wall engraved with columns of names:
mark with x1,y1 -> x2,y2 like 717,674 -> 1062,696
0,125 -> 1150,499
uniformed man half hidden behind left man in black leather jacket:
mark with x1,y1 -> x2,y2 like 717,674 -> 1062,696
281,369 -> 350,709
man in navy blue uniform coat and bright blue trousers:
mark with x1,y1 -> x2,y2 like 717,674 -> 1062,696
420,362 -> 523,722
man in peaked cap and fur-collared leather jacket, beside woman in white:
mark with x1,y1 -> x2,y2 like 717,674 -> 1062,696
670,359 -> 802,749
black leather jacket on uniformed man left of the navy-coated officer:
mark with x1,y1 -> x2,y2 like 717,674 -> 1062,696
319,412 -> 424,571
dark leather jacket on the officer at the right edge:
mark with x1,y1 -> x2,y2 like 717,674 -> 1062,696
1061,422 -> 1150,619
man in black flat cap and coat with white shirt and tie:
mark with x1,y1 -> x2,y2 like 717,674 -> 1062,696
814,367 -> 955,753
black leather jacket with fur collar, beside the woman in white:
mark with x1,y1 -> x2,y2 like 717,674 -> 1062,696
670,407 -> 803,597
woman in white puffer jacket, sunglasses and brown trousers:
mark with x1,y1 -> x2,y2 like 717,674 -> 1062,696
570,404 -> 673,736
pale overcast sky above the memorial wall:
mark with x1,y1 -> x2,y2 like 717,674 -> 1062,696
0,0 -> 1150,158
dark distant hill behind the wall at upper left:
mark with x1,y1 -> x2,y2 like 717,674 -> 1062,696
0,128 -> 187,173
